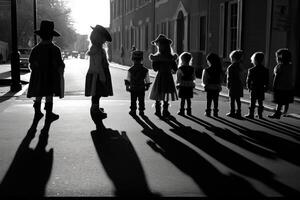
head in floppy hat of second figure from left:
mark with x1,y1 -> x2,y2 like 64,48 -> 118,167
90,25 -> 112,46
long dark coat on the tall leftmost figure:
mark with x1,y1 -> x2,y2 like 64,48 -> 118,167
27,41 -> 65,98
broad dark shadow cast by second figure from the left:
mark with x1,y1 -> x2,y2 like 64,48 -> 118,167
91,129 -> 158,196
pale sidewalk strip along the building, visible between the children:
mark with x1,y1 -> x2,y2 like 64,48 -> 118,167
110,63 -> 300,119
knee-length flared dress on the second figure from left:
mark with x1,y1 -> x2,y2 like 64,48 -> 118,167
85,46 -> 113,97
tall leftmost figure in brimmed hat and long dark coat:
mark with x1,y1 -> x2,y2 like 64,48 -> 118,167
27,20 -> 65,121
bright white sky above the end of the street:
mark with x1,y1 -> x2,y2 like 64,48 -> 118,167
65,0 -> 110,34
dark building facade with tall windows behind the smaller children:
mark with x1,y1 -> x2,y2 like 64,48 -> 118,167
110,0 -> 300,95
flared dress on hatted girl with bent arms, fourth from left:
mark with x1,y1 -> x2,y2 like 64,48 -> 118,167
149,53 -> 178,101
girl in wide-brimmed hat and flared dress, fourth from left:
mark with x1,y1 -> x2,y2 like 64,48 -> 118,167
149,34 -> 178,117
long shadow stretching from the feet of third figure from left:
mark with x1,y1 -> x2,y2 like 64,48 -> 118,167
134,116 -> 263,197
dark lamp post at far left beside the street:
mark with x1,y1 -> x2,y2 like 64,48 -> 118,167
10,0 -> 22,92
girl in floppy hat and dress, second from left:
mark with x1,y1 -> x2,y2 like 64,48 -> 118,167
85,25 -> 113,125
